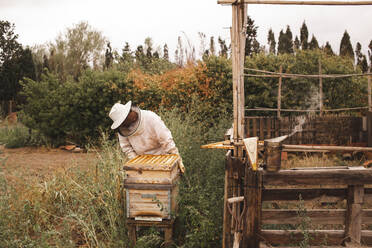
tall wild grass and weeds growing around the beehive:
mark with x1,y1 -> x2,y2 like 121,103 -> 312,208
0,104 -> 229,247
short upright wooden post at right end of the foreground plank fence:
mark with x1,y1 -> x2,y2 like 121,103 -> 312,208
345,185 -> 364,245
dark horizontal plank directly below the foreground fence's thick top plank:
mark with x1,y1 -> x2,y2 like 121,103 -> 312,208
262,188 -> 346,202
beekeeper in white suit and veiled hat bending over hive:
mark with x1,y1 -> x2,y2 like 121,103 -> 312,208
109,101 -> 184,172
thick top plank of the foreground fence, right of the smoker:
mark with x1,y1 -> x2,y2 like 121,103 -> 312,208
263,169 -> 372,186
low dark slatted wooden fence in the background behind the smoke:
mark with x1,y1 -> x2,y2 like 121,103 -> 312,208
245,115 -> 368,145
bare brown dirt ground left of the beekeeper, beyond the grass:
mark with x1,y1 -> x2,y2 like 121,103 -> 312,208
0,147 -> 97,181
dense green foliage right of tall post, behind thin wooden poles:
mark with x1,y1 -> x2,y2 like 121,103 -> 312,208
245,50 -> 367,115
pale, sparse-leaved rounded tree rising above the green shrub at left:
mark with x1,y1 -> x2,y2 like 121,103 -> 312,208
49,22 -> 106,81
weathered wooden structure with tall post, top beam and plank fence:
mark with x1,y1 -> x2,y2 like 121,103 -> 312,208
218,0 -> 372,248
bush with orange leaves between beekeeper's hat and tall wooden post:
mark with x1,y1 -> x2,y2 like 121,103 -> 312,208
129,56 -> 232,118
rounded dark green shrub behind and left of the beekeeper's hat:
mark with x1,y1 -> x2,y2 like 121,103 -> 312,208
22,71 -> 132,145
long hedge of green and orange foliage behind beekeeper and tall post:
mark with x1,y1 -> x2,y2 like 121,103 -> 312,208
18,50 -> 367,145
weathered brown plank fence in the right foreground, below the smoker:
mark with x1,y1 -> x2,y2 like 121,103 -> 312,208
223,152 -> 372,248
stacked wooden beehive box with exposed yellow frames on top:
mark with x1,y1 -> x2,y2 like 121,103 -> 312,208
124,154 -> 180,221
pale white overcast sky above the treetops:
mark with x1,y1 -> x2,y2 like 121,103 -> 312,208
0,0 -> 372,60
